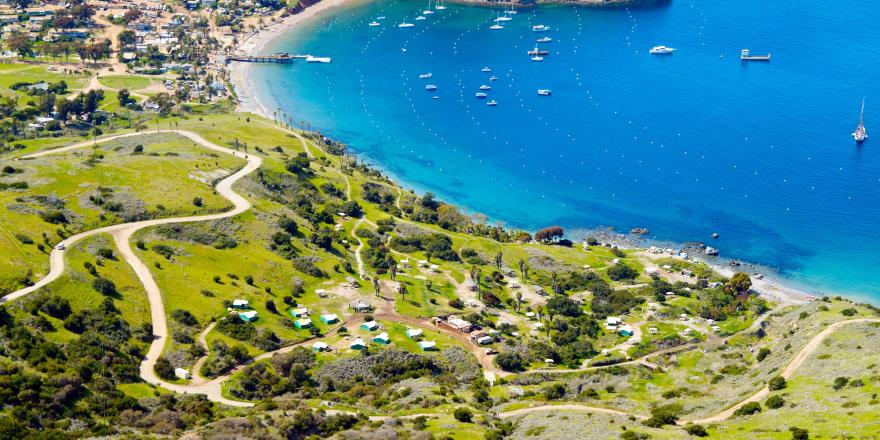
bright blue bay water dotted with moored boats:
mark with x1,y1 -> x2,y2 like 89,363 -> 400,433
252,0 -> 880,300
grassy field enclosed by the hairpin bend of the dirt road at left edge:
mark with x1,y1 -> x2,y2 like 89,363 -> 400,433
0,134 -> 243,292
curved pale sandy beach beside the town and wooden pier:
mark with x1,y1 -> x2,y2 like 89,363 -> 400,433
229,0 -> 358,119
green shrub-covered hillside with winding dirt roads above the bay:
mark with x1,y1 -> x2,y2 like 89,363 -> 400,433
0,69 -> 880,439
